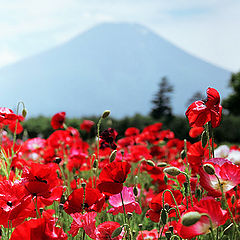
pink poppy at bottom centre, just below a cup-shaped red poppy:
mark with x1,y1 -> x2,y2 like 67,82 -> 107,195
108,187 -> 142,215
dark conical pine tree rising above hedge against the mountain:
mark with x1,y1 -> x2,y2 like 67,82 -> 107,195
150,77 -> 173,119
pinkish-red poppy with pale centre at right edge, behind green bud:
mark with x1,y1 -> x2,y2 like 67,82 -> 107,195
199,158 -> 240,197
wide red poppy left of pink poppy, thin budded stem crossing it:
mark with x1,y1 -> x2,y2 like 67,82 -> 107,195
64,188 -> 105,214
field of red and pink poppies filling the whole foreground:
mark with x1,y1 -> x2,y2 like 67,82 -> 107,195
0,88 -> 240,240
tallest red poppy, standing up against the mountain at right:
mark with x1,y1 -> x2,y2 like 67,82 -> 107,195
186,88 -> 222,128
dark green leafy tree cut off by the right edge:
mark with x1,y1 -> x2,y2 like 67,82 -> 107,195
222,72 -> 240,116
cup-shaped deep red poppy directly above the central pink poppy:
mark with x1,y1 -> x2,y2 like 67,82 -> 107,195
97,162 -> 131,196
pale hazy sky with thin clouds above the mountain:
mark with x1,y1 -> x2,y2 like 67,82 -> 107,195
0,0 -> 240,72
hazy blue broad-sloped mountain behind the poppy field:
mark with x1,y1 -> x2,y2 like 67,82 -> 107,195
0,23 -> 231,117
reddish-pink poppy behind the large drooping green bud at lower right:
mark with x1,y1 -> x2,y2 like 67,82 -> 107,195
177,198 -> 228,239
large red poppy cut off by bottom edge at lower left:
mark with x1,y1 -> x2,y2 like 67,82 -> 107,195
10,217 -> 68,240
